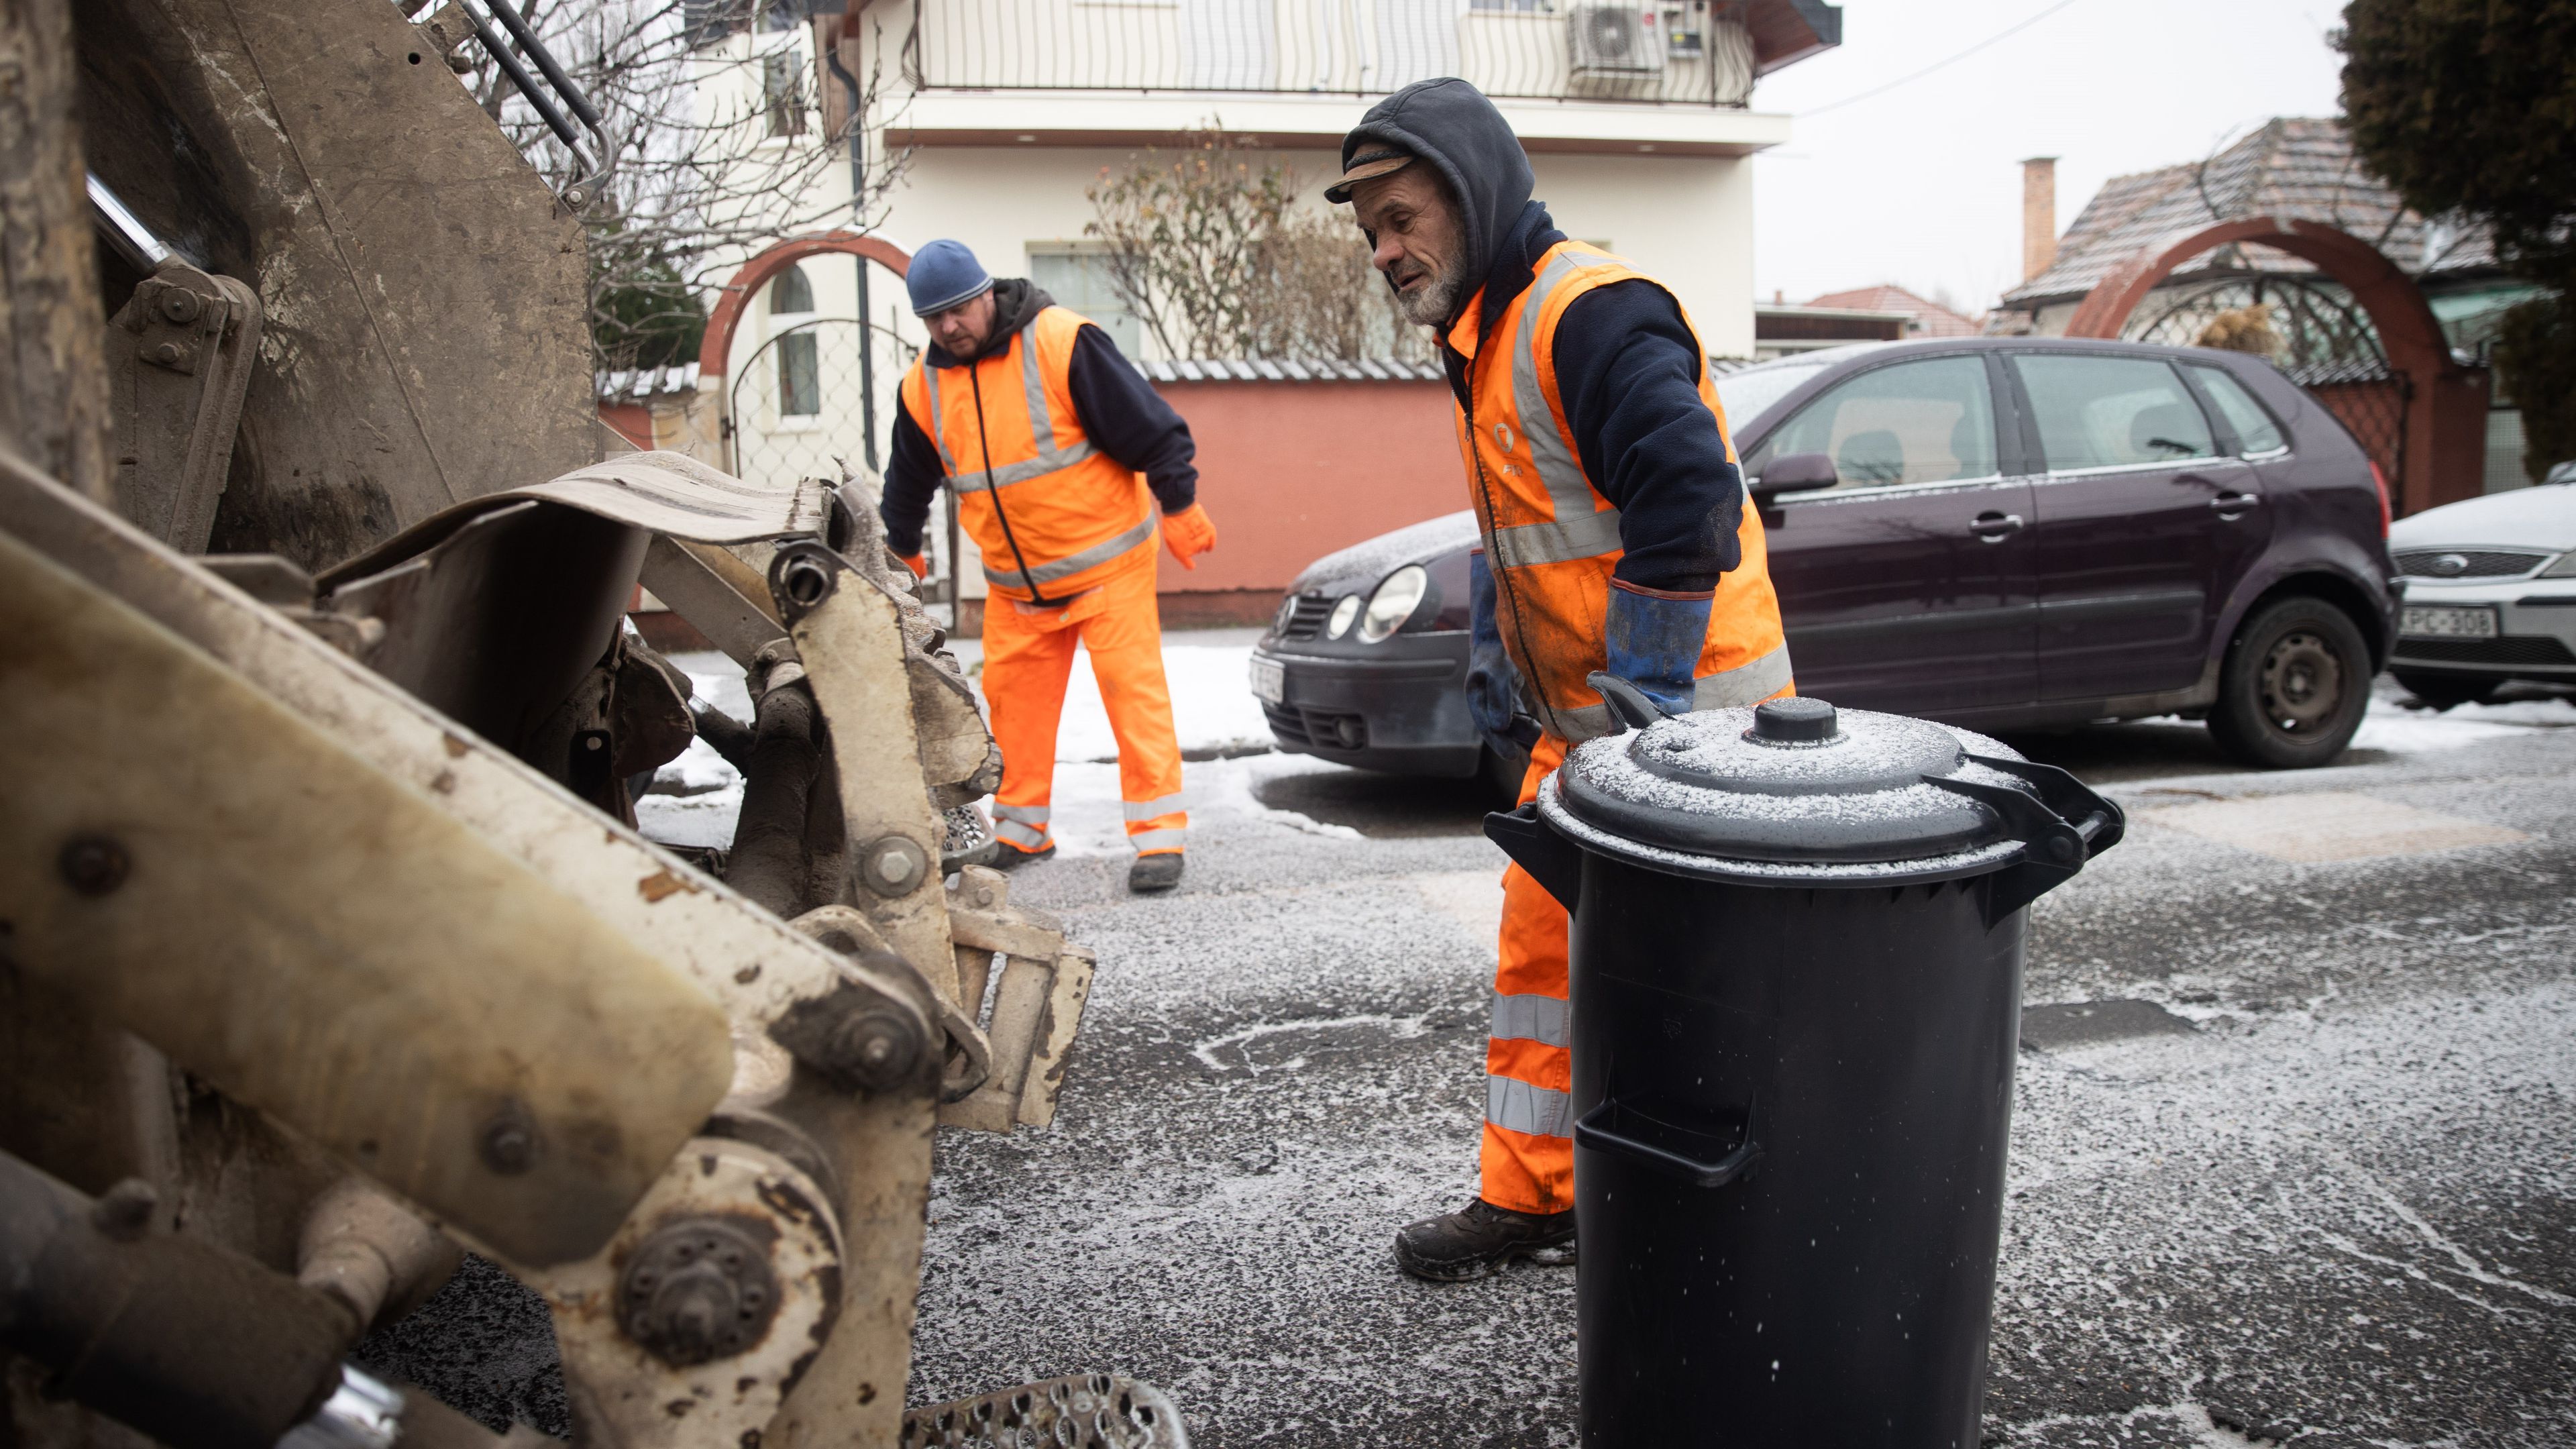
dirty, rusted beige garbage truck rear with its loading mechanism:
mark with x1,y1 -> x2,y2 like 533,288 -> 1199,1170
0,0 -> 1185,1449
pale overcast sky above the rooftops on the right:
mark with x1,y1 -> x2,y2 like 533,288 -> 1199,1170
1752,0 -> 2342,315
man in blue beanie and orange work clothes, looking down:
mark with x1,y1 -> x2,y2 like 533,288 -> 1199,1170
878,239 -> 1216,892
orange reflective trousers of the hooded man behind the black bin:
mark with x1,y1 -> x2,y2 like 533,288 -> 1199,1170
1479,735 -> 1574,1212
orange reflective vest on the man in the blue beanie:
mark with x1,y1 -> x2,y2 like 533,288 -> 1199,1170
904,307 -> 1154,601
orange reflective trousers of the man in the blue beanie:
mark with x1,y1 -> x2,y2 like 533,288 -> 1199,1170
984,549 -> 1190,856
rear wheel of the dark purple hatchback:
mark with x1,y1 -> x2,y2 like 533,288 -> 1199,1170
2210,598 -> 2370,771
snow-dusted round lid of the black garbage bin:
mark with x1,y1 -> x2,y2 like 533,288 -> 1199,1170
1548,699 -> 2022,866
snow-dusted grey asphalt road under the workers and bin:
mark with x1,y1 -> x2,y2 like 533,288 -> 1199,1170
405,637 -> 2576,1449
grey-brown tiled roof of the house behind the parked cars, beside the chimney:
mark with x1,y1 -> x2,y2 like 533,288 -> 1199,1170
2004,116 -> 2493,307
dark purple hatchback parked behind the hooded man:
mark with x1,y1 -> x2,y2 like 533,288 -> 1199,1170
1252,337 -> 2396,776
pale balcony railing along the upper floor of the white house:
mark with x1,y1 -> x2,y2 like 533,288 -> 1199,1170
904,0 -> 1754,106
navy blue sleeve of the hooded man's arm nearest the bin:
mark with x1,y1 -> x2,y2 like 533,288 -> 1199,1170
1556,281 -> 1744,593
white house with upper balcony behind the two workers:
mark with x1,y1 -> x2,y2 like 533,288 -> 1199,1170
698,0 -> 1842,608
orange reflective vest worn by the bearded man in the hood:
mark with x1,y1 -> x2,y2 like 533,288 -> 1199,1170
1450,242 -> 1790,743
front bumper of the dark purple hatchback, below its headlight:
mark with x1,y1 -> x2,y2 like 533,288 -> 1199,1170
1254,632 -> 1481,779
